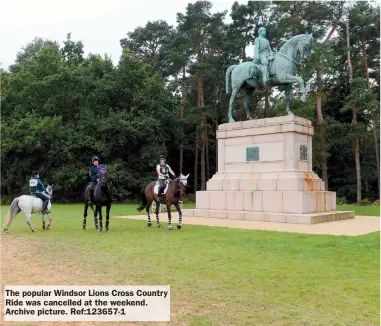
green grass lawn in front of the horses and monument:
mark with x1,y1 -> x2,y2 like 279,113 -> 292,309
1,205 -> 380,325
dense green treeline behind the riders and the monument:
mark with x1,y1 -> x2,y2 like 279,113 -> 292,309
1,1 -> 380,202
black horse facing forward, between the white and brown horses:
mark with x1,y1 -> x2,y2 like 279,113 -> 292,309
82,165 -> 112,232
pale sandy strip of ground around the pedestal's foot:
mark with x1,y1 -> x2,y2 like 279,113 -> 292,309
117,212 -> 380,236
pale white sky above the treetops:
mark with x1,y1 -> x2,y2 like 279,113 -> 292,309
0,0 -> 253,70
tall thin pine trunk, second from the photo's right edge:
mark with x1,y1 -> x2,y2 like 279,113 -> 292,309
346,19 -> 361,204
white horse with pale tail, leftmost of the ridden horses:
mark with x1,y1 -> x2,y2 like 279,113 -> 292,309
4,185 -> 53,232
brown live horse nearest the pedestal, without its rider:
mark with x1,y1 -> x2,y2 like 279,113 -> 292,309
137,174 -> 189,231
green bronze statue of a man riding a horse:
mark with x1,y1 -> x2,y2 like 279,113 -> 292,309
226,27 -> 314,122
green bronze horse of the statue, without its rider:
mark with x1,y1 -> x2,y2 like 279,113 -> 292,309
226,34 -> 314,122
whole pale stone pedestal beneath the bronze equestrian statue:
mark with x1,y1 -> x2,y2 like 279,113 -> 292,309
184,116 -> 354,224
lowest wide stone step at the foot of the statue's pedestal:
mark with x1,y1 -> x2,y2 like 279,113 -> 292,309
183,209 -> 355,224
